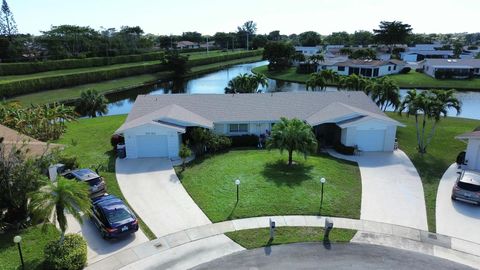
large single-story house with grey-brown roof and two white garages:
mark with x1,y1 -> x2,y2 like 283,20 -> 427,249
115,92 -> 402,158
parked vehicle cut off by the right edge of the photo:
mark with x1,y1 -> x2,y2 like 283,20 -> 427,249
452,171 -> 480,205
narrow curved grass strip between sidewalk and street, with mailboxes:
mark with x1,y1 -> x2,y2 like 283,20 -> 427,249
225,227 -> 356,249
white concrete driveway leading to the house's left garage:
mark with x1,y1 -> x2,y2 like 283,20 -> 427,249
116,158 -> 211,237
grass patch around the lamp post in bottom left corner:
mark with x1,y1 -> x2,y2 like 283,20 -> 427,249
0,225 -> 60,270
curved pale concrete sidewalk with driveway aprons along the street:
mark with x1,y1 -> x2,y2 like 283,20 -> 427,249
87,216 -> 480,270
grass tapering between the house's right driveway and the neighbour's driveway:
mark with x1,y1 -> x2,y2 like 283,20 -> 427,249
388,113 -> 480,232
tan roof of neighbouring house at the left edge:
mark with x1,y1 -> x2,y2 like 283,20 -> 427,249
0,125 -> 62,157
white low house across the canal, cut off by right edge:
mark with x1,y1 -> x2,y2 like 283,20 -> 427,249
422,59 -> 480,79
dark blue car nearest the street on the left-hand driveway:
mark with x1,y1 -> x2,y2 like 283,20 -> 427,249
92,195 -> 138,239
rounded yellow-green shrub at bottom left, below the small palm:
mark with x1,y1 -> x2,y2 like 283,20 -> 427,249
44,234 -> 87,270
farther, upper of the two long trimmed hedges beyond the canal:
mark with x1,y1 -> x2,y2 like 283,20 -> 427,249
0,52 -> 165,76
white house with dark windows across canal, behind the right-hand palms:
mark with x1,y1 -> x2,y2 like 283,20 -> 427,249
319,59 -> 406,78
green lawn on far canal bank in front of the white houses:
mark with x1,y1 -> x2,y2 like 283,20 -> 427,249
252,66 -> 480,90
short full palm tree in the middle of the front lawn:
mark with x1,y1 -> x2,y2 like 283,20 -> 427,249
267,117 -> 317,166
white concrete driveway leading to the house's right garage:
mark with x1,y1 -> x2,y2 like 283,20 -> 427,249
327,150 -> 428,230
